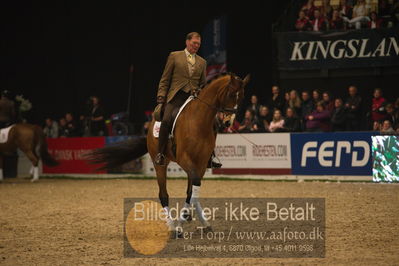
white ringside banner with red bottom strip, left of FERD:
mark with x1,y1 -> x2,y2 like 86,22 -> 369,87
213,133 -> 291,175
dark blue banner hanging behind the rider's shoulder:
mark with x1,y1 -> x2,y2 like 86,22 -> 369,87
201,16 -> 227,80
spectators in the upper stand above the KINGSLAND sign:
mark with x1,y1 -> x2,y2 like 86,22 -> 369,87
295,0 -> 399,31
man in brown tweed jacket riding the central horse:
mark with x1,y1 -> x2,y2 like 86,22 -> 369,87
154,32 -> 221,168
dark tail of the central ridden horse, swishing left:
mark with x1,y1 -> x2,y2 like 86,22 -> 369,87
87,136 -> 148,170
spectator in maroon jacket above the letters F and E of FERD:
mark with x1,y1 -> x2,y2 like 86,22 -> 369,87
305,101 -> 331,132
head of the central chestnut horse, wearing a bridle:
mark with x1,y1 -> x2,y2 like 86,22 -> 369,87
218,73 -> 250,114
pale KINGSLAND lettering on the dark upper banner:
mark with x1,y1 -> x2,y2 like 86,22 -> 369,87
290,37 -> 399,61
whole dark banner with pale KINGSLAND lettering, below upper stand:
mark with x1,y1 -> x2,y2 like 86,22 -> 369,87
276,27 -> 399,70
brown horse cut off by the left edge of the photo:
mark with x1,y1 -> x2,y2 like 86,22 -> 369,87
0,123 -> 58,182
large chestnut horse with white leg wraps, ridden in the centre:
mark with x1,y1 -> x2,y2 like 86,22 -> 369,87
89,73 -> 249,236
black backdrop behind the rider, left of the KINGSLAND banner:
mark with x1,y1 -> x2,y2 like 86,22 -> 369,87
0,1 -> 272,128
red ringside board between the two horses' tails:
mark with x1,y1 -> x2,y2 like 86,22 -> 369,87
43,137 -> 106,174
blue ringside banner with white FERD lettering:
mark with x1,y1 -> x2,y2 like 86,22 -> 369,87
291,132 -> 376,176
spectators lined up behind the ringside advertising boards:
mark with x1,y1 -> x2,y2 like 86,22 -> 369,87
43,86 -> 399,138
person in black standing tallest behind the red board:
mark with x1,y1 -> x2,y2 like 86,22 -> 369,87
89,96 -> 107,136
